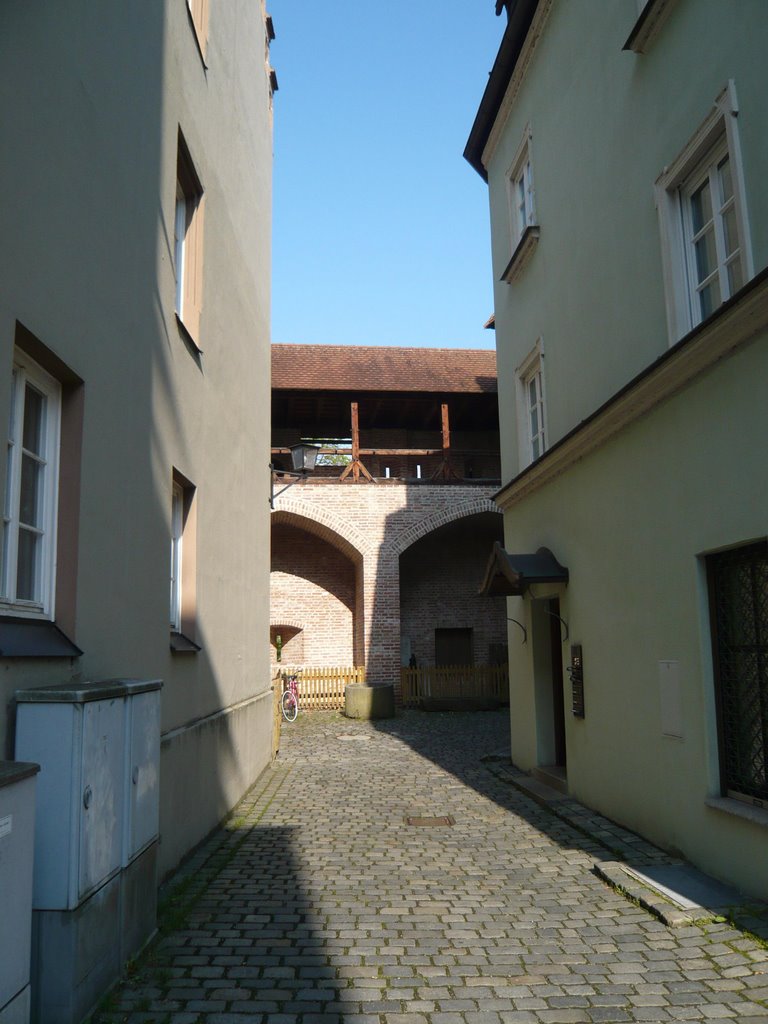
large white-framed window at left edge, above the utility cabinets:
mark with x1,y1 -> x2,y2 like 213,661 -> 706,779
1,351 -> 61,618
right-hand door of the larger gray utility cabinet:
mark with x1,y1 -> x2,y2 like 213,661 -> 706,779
123,690 -> 160,864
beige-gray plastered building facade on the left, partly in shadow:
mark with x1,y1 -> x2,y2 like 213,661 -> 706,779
0,0 -> 274,874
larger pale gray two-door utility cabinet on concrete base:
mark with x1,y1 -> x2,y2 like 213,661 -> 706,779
15,679 -> 162,1024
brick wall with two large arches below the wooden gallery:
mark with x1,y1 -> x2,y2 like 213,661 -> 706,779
270,480 -> 506,684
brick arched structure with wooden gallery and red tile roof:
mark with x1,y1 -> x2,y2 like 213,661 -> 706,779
270,345 -> 506,687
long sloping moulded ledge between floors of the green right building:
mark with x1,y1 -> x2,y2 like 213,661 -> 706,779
493,267 -> 768,511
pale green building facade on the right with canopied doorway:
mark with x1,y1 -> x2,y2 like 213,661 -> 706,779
465,0 -> 768,896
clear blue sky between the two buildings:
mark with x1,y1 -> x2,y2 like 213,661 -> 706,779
269,0 -> 506,348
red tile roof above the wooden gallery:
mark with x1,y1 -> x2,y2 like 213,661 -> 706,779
272,345 -> 497,394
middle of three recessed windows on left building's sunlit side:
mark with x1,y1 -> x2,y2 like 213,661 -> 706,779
174,132 -> 203,344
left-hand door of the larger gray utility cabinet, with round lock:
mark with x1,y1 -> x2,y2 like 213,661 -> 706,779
78,698 -> 125,899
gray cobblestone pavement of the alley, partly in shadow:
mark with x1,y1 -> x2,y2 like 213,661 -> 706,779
94,712 -> 768,1024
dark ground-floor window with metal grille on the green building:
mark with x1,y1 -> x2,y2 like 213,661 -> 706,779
707,541 -> 768,806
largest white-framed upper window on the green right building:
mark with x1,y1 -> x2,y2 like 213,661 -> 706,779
656,83 -> 754,344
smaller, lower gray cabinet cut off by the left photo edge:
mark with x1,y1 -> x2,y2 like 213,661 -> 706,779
0,761 -> 40,1024
